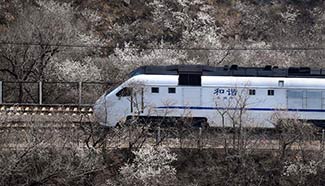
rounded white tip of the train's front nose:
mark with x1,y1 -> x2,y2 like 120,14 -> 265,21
93,95 -> 107,125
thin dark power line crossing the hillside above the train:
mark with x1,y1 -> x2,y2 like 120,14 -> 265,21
0,41 -> 325,51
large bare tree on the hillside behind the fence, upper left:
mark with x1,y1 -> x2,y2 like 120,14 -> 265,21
0,0 -> 104,102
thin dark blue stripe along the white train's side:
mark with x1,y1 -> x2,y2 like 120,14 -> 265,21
156,106 -> 325,112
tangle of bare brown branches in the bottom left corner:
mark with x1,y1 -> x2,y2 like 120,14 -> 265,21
0,116 -> 105,185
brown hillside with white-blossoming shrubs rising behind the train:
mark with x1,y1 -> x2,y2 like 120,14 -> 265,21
0,0 -> 325,80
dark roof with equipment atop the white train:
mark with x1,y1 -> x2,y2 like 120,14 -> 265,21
130,65 -> 325,78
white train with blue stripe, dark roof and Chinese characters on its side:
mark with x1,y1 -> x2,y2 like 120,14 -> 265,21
93,65 -> 325,128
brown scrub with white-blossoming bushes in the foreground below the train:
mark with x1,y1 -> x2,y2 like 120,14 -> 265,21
0,114 -> 325,185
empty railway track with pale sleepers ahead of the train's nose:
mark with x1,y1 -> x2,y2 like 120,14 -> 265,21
0,104 -> 95,129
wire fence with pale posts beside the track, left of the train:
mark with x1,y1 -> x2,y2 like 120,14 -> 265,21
0,81 -> 114,105
